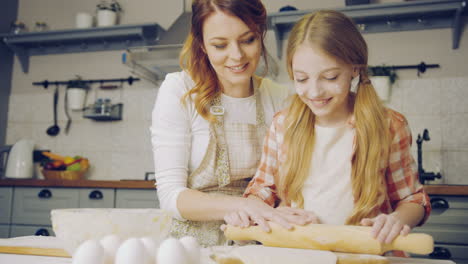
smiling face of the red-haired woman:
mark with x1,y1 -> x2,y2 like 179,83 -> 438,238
203,11 -> 262,87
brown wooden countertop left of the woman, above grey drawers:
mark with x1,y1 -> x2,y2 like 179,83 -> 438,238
0,179 -> 156,189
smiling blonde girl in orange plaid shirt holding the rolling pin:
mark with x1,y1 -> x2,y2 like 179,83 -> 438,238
225,11 -> 430,252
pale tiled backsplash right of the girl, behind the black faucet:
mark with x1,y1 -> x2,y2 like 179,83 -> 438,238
388,77 -> 468,184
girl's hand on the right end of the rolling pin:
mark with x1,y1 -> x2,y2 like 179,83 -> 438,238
361,212 -> 411,244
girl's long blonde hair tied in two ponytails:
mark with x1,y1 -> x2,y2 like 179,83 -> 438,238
279,10 -> 390,224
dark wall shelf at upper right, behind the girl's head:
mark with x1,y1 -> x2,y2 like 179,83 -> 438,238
268,0 -> 467,58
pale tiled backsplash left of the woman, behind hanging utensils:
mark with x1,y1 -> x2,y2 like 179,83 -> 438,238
6,63 -> 157,180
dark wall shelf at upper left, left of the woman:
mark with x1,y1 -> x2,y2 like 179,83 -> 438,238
0,23 -> 165,73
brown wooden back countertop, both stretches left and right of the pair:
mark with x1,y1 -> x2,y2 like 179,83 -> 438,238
0,179 -> 468,195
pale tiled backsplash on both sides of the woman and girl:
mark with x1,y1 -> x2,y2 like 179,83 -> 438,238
7,70 -> 468,184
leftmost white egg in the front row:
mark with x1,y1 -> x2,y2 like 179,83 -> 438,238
72,240 -> 104,264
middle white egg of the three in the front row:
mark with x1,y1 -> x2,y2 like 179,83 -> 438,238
114,238 -> 154,264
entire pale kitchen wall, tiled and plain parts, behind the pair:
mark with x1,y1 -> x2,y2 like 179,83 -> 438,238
7,0 -> 468,184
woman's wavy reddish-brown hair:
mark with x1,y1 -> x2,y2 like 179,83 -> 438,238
180,0 -> 268,122
